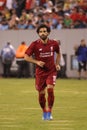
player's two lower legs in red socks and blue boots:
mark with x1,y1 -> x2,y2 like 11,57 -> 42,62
39,84 -> 54,120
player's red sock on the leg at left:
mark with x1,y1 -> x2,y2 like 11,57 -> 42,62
39,93 -> 46,112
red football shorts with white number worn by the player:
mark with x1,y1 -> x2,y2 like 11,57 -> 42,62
35,72 -> 57,91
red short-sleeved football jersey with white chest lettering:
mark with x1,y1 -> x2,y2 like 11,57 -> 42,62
25,39 -> 60,75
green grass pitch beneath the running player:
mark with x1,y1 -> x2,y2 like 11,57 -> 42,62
0,78 -> 87,130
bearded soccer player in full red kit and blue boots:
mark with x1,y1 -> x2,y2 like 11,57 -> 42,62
25,24 -> 60,120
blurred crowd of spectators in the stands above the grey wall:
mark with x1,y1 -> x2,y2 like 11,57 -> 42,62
0,0 -> 87,30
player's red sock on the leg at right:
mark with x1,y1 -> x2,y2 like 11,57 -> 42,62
47,88 -> 54,111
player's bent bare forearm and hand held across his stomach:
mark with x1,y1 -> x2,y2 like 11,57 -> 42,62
24,54 -> 45,67
